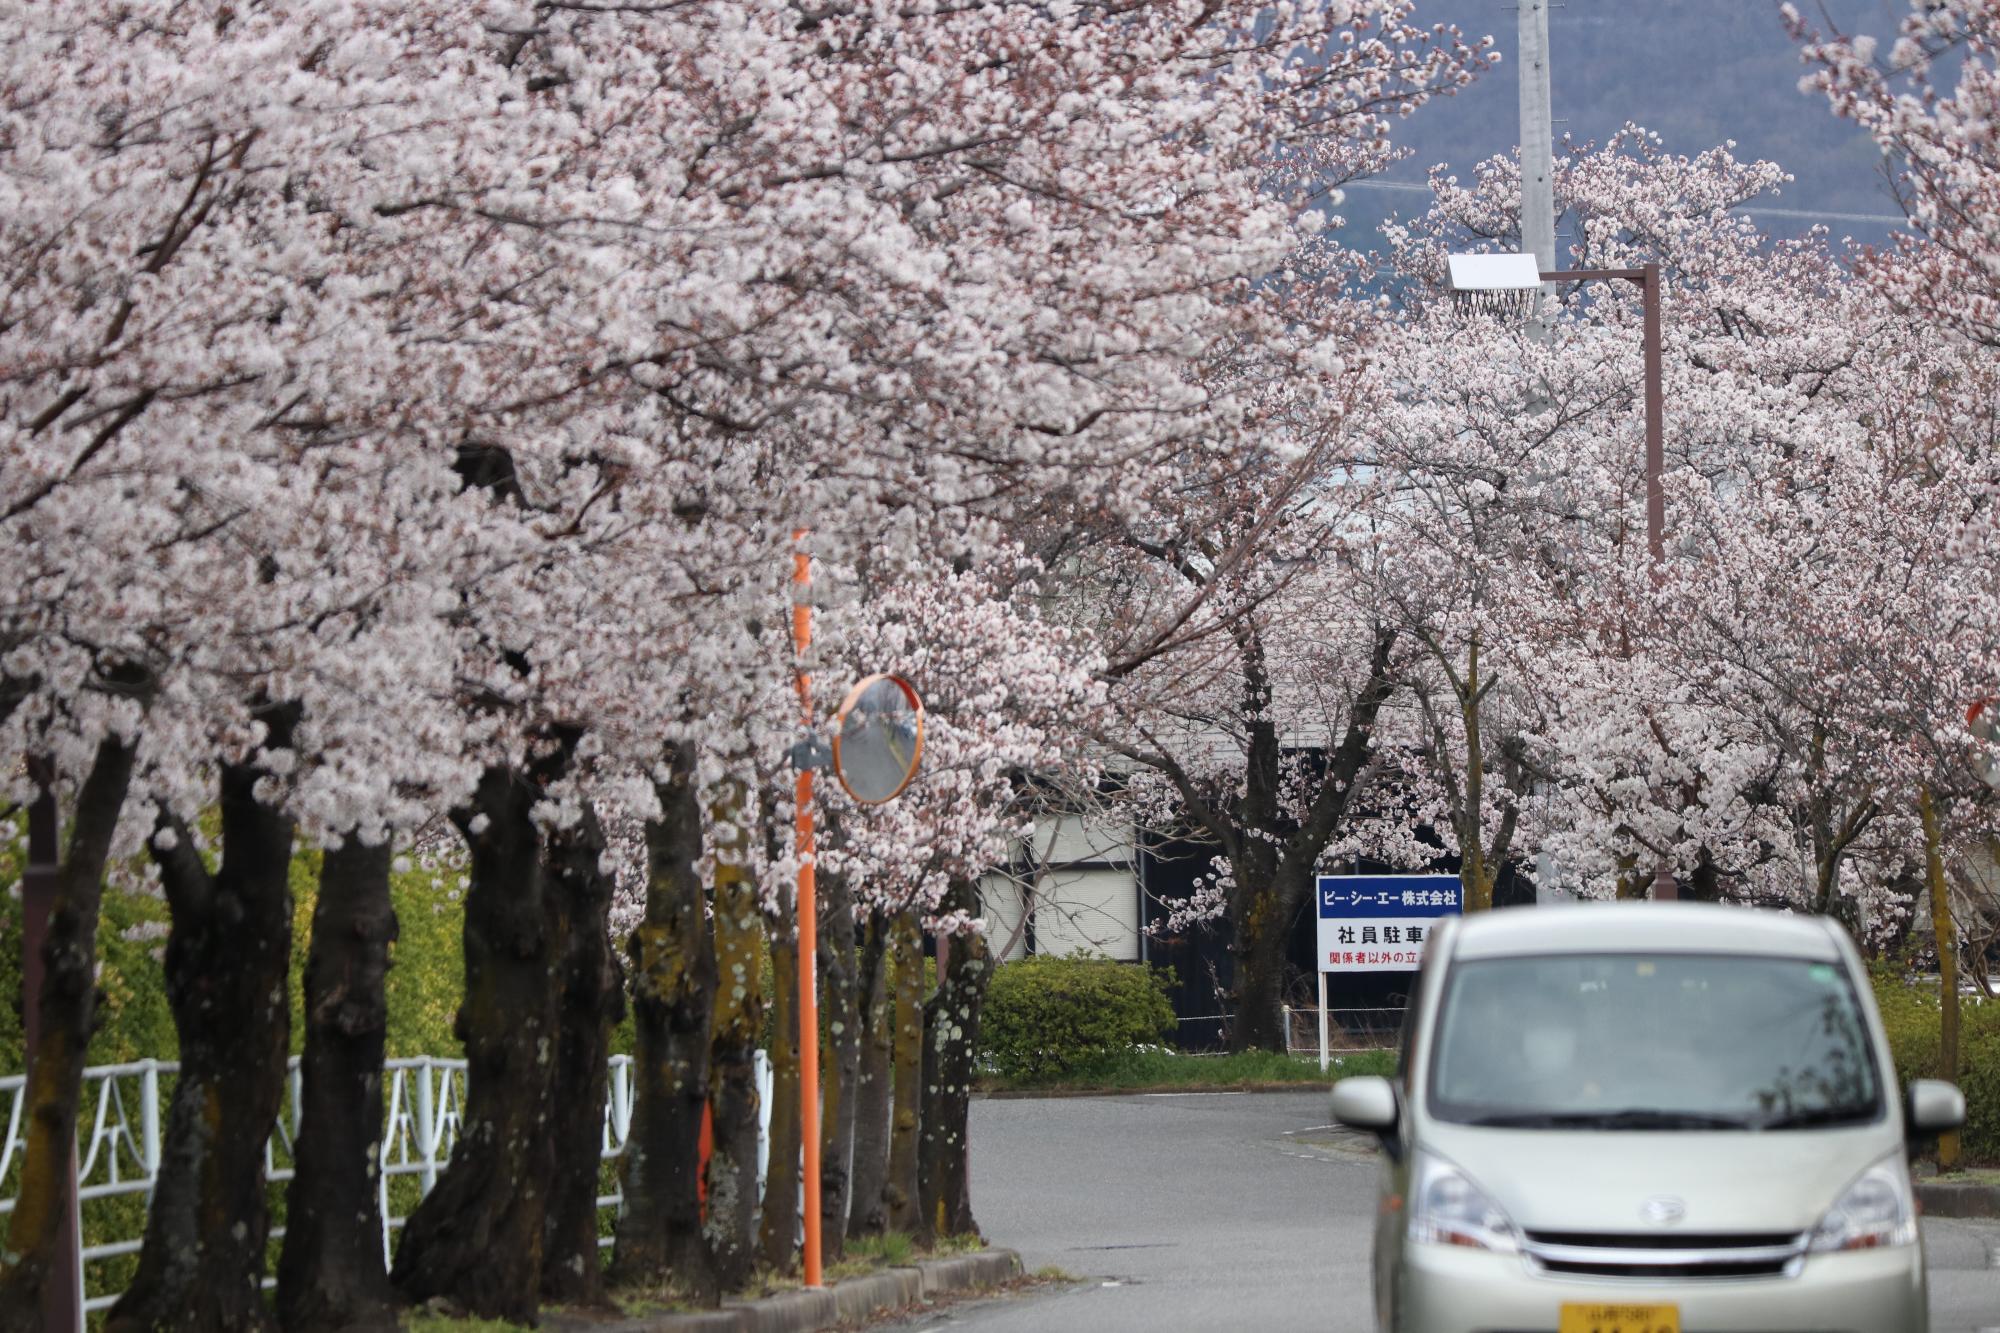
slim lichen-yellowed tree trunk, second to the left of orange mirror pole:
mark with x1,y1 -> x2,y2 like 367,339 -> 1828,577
702,781 -> 764,1291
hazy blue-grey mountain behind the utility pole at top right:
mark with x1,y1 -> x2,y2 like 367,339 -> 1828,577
1340,0 -> 1908,248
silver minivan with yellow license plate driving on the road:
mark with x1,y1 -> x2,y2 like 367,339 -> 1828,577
1334,903 -> 1966,1333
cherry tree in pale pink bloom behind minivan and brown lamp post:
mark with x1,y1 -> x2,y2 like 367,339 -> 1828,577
1392,132 -> 1992,925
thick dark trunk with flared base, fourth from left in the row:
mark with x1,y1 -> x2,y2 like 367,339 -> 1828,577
390,769 -> 558,1323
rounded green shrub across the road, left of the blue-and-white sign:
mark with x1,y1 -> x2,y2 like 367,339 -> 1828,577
980,955 -> 1174,1083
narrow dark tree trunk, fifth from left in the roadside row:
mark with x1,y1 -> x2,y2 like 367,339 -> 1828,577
542,805 -> 624,1305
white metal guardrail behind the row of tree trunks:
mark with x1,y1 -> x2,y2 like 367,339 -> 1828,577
0,1051 -> 770,1311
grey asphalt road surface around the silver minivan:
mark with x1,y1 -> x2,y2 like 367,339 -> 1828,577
902,1091 -> 2000,1333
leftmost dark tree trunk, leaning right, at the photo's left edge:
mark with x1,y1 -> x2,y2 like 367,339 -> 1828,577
0,739 -> 134,1333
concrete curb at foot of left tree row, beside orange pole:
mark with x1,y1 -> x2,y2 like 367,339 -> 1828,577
542,1249 -> 1022,1333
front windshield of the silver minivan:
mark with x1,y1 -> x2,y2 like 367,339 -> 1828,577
1430,953 -> 1882,1129
